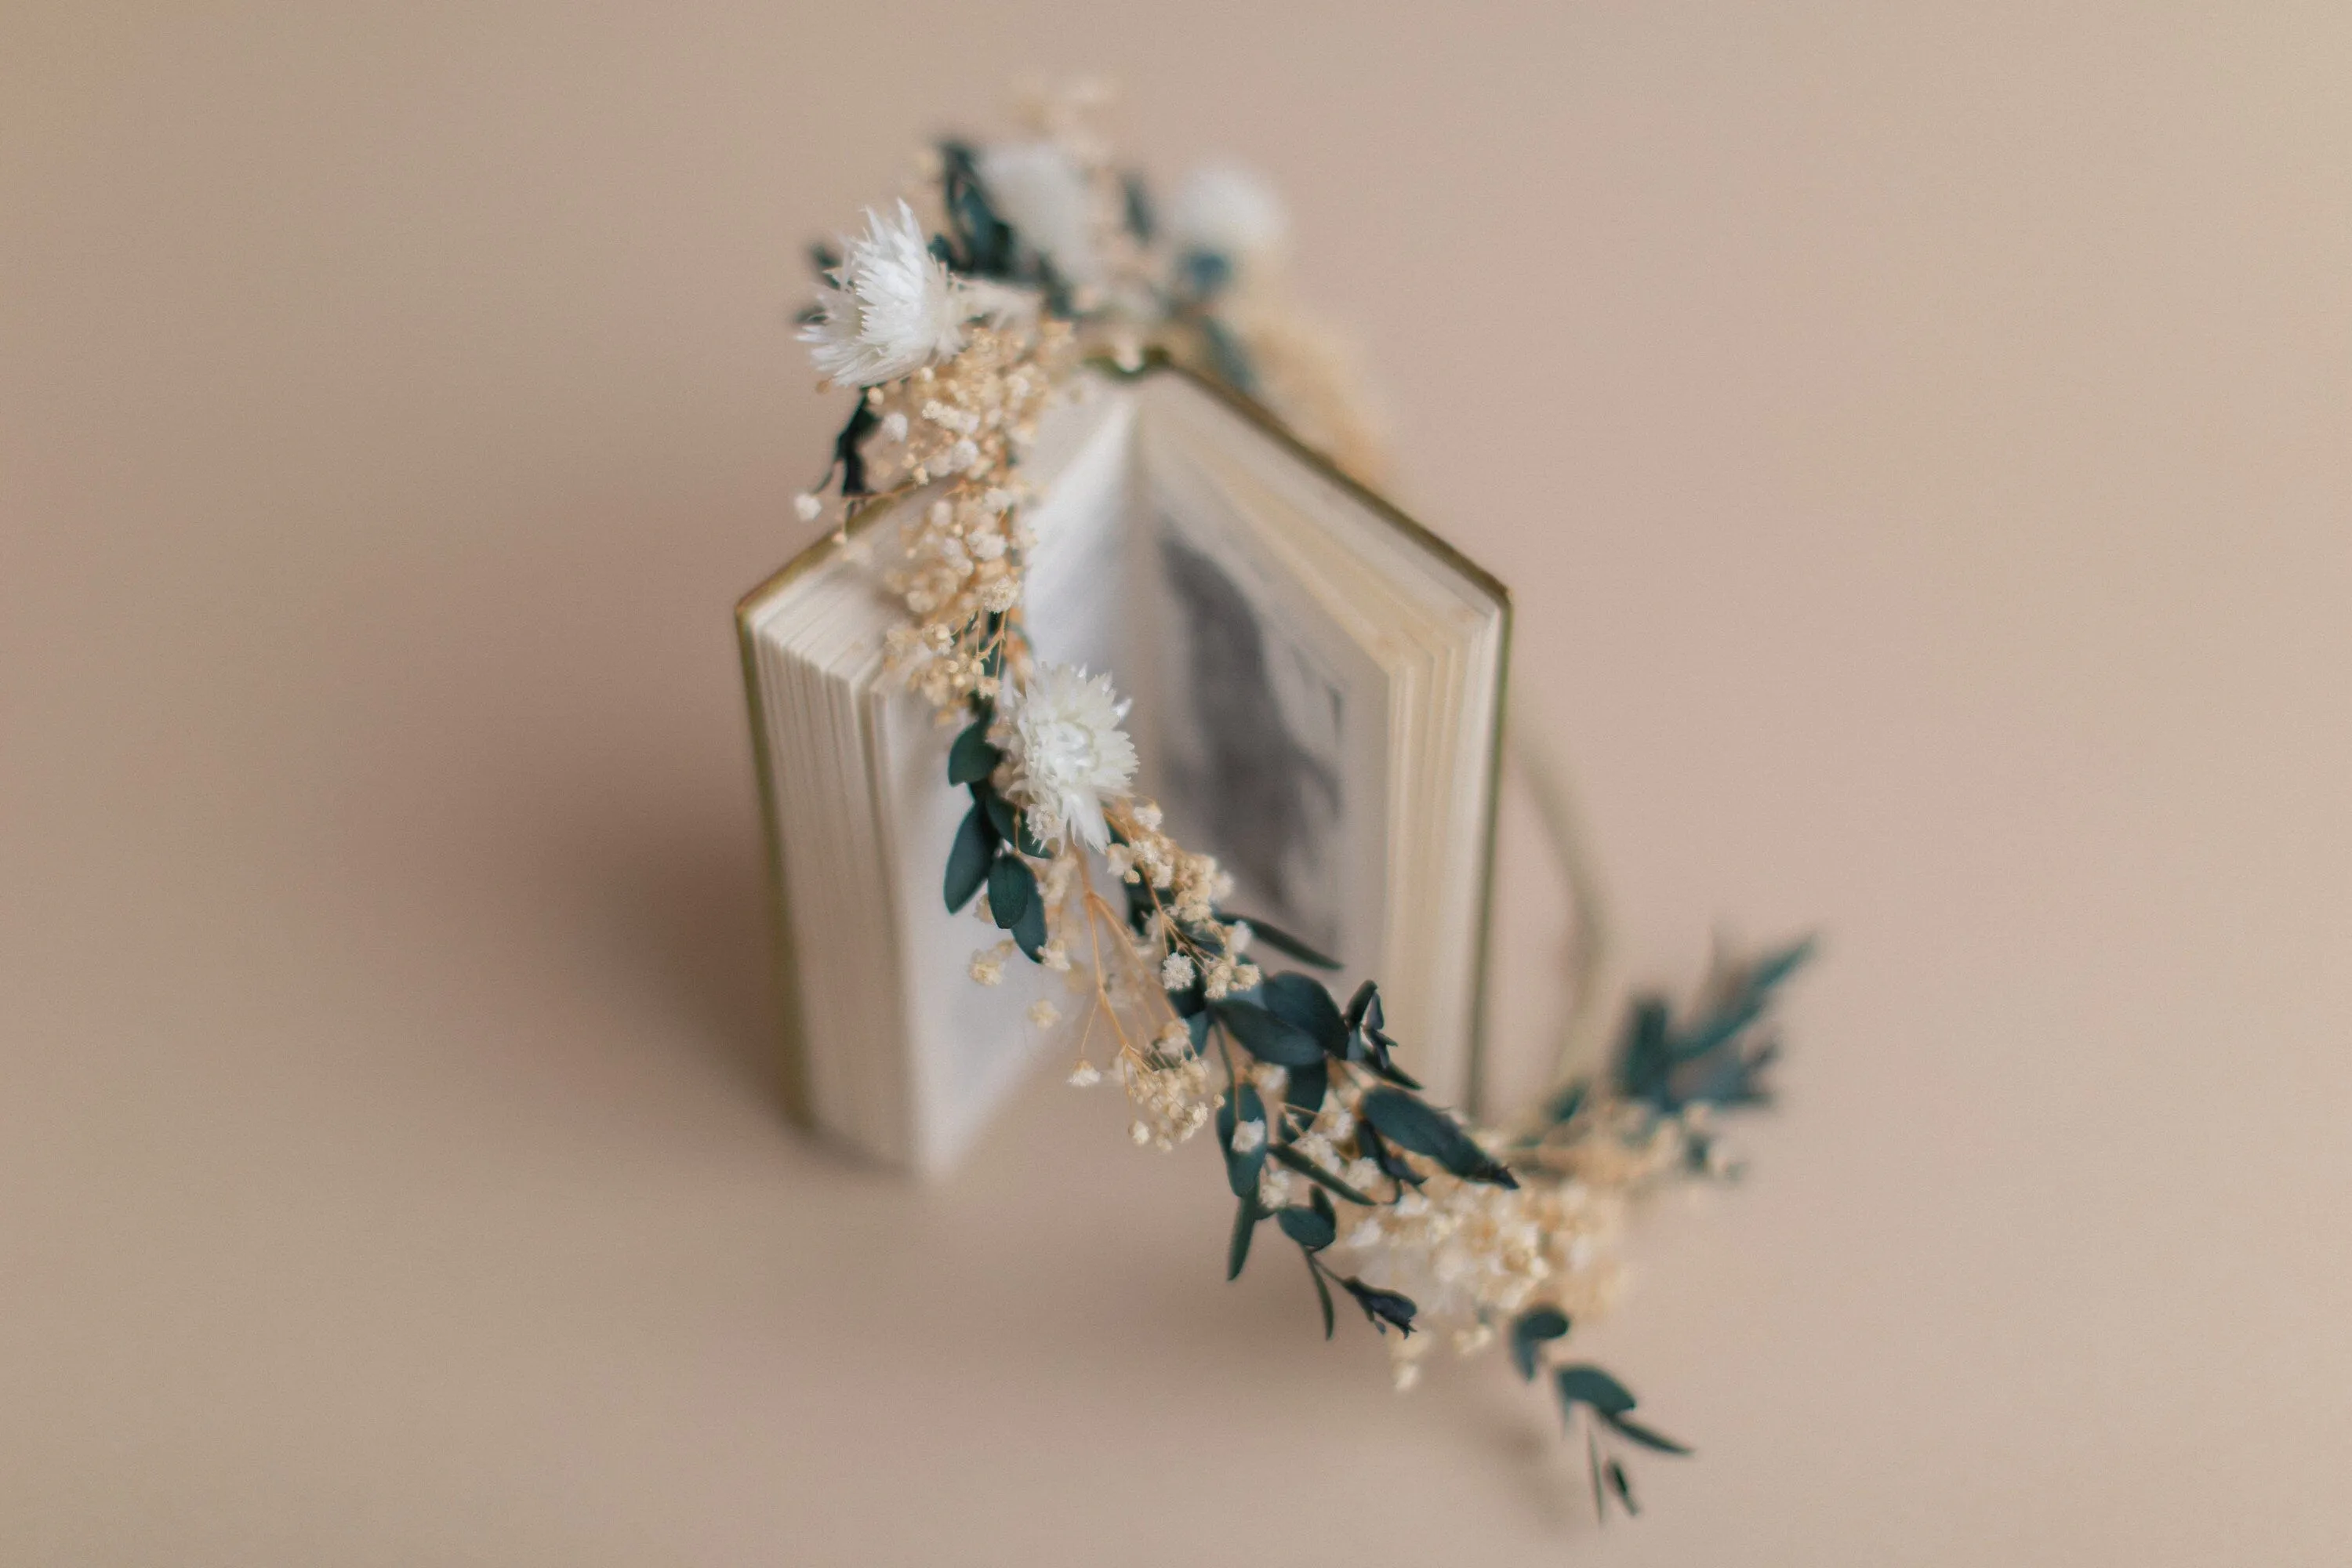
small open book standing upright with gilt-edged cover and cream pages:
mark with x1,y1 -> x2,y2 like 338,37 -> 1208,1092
736,369 -> 1510,1171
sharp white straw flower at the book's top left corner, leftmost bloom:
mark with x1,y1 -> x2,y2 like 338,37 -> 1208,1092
800,202 -> 981,386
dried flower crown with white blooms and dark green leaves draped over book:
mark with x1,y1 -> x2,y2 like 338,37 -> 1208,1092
795,94 -> 1809,1514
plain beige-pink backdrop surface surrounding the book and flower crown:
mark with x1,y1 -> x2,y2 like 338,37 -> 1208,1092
0,0 -> 2352,1566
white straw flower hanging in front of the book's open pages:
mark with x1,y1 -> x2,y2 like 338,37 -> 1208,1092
997,666 -> 1136,848
